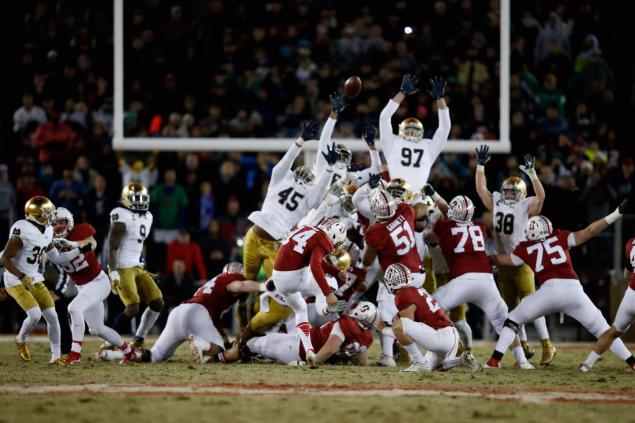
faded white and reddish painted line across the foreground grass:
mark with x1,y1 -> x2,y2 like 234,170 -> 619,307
0,384 -> 635,404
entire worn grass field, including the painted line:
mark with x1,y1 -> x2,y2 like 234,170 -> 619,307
0,340 -> 635,423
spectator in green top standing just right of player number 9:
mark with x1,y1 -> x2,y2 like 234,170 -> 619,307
150,169 -> 188,244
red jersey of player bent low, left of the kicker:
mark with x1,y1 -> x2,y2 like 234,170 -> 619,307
183,273 -> 245,328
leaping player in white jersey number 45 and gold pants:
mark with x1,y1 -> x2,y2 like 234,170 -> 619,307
243,121 -> 337,280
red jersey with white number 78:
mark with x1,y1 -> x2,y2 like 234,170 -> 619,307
432,219 -> 492,279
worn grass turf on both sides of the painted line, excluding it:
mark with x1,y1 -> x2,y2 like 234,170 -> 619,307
0,341 -> 635,423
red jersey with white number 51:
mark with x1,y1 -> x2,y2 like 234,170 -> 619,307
365,203 -> 421,272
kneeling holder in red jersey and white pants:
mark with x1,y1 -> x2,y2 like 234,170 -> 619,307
384,263 -> 482,372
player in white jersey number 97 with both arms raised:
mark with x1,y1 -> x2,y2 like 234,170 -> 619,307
379,75 -> 451,192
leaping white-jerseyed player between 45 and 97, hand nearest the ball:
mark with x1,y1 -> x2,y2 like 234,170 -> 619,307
314,93 -> 381,185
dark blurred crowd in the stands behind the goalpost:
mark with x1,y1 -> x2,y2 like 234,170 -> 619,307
0,0 -> 635,338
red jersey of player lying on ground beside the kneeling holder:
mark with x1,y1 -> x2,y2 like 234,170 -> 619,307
300,315 -> 373,360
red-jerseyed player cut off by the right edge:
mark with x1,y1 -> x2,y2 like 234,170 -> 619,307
580,238 -> 635,372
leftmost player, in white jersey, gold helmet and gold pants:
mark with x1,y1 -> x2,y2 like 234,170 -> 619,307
2,196 -> 65,364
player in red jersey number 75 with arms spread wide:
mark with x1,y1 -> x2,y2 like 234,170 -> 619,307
487,202 -> 635,368
